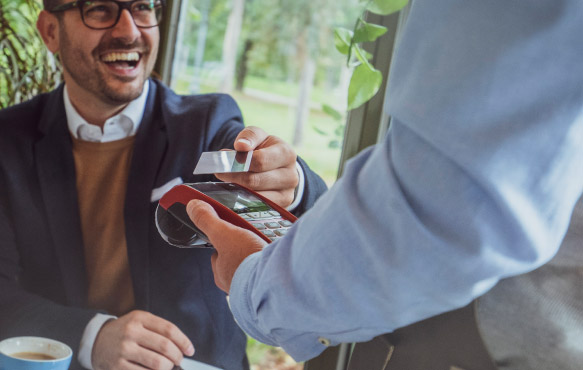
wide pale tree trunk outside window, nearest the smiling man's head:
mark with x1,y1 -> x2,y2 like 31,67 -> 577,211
219,0 -> 245,93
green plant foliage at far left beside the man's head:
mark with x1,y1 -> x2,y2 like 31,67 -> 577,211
0,0 -> 61,109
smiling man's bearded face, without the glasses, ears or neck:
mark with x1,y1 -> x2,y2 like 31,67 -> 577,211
50,0 -> 160,105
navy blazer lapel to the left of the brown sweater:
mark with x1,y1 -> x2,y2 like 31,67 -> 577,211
35,85 -> 87,307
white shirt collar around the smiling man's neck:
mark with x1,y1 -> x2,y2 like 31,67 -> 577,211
63,80 -> 150,143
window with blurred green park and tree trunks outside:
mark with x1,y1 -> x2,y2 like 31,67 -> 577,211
165,0 -> 362,186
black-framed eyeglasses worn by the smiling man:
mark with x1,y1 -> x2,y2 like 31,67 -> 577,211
50,0 -> 165,30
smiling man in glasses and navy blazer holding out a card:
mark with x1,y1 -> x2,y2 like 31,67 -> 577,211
0,0 -> 325,370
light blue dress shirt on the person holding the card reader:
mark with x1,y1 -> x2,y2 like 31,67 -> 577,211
230,0 -> 583,361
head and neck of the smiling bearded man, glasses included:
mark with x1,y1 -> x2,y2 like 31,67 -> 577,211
38,0 -> 163,120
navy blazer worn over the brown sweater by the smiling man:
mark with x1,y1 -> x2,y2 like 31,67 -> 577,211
0,80 -> 326,370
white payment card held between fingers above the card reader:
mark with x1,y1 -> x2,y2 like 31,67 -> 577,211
193,150 -> 253,175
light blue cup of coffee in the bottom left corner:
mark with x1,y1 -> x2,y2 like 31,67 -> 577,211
0,337 -> 73,370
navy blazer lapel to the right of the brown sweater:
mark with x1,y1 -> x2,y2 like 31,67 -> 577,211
124,82 -> 167,309
